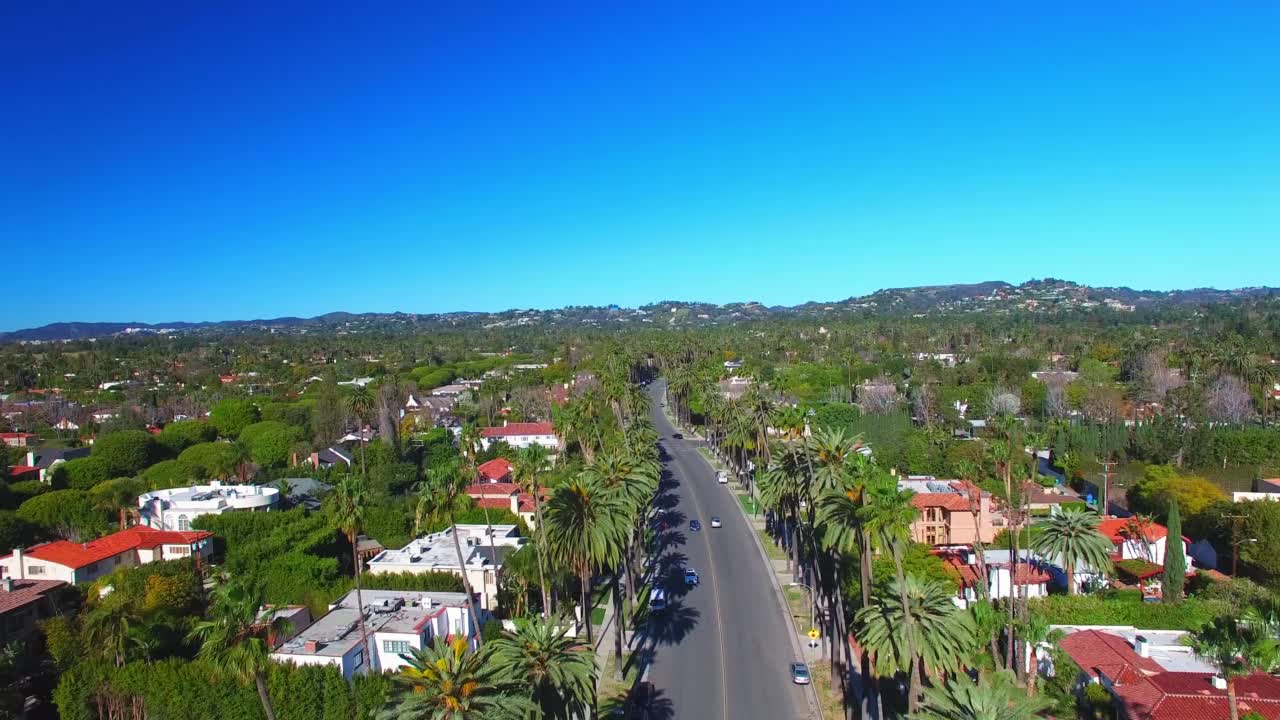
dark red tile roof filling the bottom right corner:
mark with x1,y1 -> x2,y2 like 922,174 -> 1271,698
1115,673 -> 1280,720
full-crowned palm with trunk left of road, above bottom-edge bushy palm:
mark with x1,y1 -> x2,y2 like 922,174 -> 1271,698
547,479 -> 630,642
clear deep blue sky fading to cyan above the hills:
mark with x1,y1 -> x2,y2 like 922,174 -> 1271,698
0,0 -> 1280,329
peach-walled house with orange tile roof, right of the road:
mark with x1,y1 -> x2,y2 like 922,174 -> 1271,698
897,475 -> 1006,546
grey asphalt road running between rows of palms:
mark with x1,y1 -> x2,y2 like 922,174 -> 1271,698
637,380 -> 809,720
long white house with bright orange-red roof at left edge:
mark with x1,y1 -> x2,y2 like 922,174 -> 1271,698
0,525 -> 214,584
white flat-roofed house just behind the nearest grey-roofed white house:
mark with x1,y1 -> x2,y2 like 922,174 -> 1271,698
367,525 -> 526,609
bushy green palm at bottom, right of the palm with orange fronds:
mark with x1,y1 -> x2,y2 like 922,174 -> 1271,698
489,615 -> 596,720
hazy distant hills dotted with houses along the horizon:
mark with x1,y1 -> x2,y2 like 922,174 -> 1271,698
0,278 -> 1280,342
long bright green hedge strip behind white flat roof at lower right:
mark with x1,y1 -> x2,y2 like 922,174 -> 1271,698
1030,594 -> 1225,630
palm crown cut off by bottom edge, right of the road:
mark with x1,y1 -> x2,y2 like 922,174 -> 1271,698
911,671 -> 1050,720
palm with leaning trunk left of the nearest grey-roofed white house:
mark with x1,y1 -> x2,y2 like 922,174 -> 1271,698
191,583 -> 288,720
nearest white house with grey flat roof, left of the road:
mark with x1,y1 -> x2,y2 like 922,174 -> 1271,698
270,589 -> 489,679
